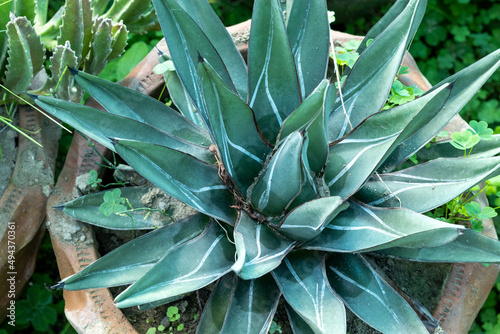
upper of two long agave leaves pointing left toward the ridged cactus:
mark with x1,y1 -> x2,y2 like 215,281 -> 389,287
72,70 -> 211,146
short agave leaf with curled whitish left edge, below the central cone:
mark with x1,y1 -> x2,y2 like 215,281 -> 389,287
231,211 -> 296,279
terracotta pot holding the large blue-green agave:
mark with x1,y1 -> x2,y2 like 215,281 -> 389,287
48,21 -> 499,334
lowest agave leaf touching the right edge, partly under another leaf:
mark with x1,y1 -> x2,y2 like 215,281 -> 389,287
380,229 -> 500,263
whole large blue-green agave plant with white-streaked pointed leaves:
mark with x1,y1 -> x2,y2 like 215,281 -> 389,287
35,0 -> 500,333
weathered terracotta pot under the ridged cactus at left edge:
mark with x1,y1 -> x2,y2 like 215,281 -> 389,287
0,100 -> 61,322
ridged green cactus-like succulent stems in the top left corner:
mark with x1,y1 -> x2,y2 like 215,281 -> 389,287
0,0 -> 157,102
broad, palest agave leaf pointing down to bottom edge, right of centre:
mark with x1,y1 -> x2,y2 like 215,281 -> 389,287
272,251 -> 346,334
